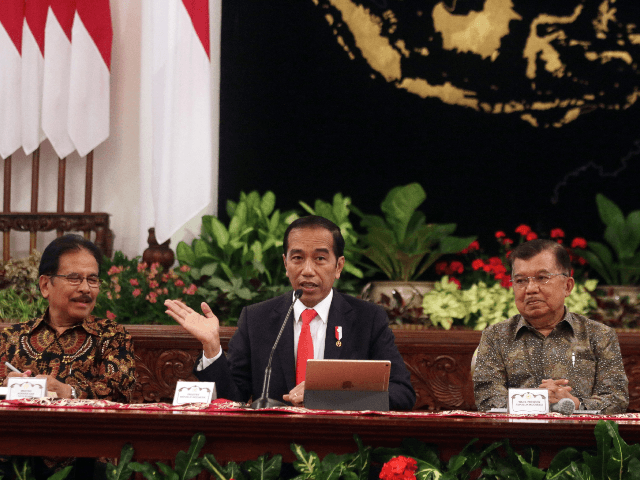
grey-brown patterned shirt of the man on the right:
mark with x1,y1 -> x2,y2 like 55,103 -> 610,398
473,311 -> 629,414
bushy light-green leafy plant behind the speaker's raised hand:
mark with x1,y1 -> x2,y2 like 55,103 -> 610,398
176,191 -> 298,325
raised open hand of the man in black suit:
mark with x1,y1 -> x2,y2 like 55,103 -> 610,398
164,300 -> 220,358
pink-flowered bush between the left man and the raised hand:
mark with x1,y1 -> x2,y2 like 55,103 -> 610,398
94,252 -> 203,325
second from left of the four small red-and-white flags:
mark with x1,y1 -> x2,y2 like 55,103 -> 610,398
22,0 -> 49,155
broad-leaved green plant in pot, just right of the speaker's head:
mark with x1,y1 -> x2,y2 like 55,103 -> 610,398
352,183 -> 476,318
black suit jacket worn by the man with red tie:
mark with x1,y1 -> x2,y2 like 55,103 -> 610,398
194,290 -> 416,410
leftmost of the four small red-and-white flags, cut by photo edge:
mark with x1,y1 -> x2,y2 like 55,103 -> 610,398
0,0 -> 25,158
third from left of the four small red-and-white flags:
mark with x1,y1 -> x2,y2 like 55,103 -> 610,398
42,0 -> 76,158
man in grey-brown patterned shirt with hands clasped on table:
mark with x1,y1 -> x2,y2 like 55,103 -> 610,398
473,240 -> 629,414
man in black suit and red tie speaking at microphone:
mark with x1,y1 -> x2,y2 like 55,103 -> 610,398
165,216 -> 416,410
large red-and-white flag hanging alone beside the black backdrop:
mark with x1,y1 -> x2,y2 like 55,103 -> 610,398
151,0 -> 213,242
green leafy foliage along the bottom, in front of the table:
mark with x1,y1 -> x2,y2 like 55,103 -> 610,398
43,420 -> 640,480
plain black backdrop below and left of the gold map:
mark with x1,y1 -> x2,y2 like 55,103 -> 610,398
219,0 -> 640,248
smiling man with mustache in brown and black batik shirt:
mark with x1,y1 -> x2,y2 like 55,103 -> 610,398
0,235 -> 135,402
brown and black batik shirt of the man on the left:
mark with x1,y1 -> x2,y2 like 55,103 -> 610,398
0,310 -> 135,403
